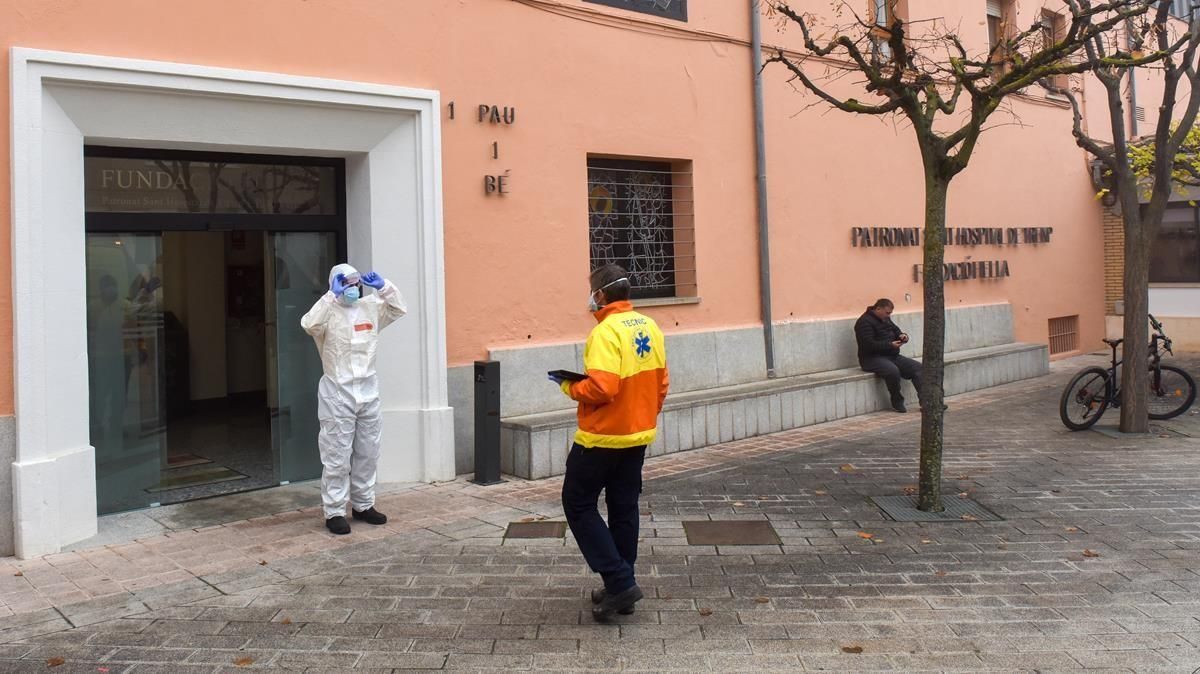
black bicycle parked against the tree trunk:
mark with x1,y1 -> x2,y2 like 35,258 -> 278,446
1058,315 -> 1196,431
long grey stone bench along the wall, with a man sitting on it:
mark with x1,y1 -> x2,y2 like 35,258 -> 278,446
500,343 -> 1049,480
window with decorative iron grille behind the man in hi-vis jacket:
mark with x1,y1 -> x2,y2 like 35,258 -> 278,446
588,158 -> 696,299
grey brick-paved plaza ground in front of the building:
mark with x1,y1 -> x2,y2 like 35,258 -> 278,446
0,356 -> 1200,673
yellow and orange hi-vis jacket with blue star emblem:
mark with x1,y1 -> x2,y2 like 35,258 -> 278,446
563,301 -> 668,449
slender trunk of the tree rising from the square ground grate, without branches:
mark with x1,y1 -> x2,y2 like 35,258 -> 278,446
917,172 -> 950,512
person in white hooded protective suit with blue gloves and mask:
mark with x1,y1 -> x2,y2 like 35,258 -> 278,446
300,264 -> 408,535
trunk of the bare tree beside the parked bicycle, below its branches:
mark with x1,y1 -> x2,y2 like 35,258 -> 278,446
1121,223 -> 1150,433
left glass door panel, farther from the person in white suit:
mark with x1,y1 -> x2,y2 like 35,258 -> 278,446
86,233 -> 168,513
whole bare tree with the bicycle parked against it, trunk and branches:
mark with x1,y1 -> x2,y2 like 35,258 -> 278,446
1063,0 -> 1200,433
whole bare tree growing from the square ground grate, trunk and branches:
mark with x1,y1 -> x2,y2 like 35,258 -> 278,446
767,0 -> 1157,512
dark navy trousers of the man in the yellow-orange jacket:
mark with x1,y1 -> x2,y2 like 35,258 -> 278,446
563,444 -> 646,594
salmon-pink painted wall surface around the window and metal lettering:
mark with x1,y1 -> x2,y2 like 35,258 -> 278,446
0,0 -> 1118,414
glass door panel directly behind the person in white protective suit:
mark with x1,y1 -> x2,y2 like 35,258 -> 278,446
264,231 -> 337,483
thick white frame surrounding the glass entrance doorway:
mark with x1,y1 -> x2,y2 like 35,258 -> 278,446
11,48 -> 455,558
